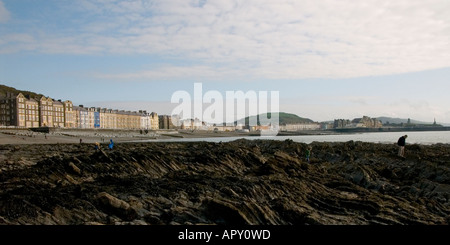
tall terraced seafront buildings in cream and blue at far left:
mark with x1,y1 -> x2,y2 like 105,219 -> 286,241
0,93 -> 164,130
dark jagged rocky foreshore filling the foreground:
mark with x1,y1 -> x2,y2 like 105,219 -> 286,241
0,140 -> 450,225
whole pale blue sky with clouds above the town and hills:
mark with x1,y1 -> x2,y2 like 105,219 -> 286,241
0,0 -> 450,123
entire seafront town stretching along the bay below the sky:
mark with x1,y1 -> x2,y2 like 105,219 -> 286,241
0,86 -> 442,132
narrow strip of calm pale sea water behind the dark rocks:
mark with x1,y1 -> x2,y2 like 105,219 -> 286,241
143,131 -> 450,145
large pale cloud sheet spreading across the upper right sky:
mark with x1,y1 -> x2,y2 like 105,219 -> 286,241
0,0 -> 450,79
